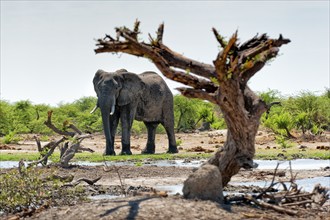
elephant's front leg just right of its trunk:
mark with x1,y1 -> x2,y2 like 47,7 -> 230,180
120,105 -> 135,155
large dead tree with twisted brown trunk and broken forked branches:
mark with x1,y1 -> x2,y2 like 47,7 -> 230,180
95,21 -> 290,201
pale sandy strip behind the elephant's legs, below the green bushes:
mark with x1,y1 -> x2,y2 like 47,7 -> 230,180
0,130 -> 330,154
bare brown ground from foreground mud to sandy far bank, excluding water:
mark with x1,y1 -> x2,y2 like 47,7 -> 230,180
0,131 -> 330,219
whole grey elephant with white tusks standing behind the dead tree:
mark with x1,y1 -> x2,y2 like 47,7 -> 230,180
92,69 -> 178,155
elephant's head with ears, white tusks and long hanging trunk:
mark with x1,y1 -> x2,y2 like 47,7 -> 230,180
92,69 -> 144,155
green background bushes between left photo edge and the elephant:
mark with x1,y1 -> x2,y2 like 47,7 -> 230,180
0,97 -> 102,136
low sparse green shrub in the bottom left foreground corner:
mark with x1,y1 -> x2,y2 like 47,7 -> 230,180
0,166 -> 85,213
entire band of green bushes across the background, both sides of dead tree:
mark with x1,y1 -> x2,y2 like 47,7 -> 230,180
0,90 -> 330,138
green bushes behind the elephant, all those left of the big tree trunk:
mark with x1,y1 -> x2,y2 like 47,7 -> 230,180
0,95 -> 224,137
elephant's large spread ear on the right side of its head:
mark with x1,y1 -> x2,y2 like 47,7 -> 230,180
117,72 -> 144,106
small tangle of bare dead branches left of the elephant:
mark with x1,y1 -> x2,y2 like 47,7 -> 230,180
29,111 -> 94,167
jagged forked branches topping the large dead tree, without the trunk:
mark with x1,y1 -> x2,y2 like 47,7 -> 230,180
95,21 -> 290,102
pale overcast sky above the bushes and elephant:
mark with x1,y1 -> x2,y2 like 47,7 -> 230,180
0,0 -> 330,105
